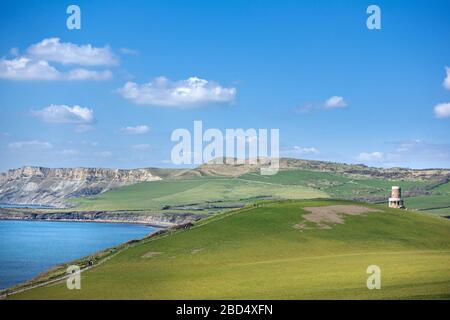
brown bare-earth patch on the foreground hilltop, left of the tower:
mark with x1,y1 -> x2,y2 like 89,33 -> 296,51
294,205 -> 381,230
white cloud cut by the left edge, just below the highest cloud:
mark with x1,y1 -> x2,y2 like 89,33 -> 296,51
0,57 -> 61,80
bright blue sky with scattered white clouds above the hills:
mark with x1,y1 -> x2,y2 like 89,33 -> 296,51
0,0 -> 450,171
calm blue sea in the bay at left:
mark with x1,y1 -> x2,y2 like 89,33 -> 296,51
0,220 -> 157,288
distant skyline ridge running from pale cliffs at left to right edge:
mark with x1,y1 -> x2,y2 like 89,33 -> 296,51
0,158 -> 450,207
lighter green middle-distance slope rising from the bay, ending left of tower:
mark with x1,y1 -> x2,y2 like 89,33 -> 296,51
75,178 -> 327,210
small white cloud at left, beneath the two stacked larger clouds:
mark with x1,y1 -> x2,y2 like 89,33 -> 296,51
32,104 -> 94,124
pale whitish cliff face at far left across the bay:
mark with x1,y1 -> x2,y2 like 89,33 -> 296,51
0,167 -> 161,207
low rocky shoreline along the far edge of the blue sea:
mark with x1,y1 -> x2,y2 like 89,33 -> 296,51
0,208 -> 204,228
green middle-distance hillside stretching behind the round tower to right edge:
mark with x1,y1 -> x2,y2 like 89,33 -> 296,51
73,169 -> 450,215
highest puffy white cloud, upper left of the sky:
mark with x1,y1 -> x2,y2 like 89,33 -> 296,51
27,38 -> 118,66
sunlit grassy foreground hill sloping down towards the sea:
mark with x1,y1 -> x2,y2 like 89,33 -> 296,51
12,200 -> 450,299
